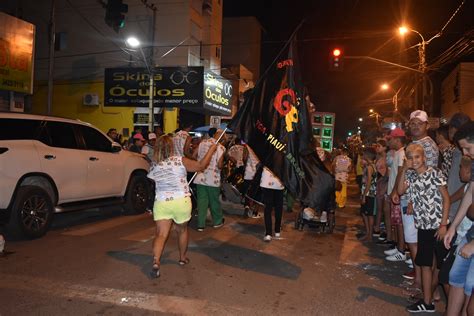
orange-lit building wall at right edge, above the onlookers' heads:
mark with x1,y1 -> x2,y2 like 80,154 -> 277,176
441,63 -> 474,118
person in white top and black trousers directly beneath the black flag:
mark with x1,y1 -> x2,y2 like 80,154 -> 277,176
260,167 -> 285,242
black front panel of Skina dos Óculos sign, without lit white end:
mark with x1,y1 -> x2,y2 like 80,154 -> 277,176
104,67 -> 203,107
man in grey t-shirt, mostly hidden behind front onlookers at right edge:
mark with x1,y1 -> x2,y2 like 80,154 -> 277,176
448,112 -> 471,222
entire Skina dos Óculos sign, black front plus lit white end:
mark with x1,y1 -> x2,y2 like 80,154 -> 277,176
104,66 -> 232,115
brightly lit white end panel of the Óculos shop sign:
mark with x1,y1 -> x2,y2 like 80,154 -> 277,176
204,71 -> 232,115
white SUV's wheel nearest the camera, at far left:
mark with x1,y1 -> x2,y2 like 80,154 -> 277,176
9,185 -> 54,239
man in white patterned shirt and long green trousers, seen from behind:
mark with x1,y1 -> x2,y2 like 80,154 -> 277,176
194,128 -> 225,231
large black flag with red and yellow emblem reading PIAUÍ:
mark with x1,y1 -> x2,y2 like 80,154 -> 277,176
228,36 -> 335,211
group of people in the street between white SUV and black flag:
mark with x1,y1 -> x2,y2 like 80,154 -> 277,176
114,124 -> 292,277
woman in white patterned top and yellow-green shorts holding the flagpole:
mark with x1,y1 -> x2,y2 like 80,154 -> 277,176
148,135 -> 217,278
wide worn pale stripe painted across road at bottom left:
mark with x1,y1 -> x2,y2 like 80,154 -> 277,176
0,274 -> 244,315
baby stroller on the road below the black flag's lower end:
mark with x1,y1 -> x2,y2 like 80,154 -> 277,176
295,207 -> 336,234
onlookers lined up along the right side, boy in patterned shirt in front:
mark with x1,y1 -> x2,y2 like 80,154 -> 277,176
357,110 -> 474,316
